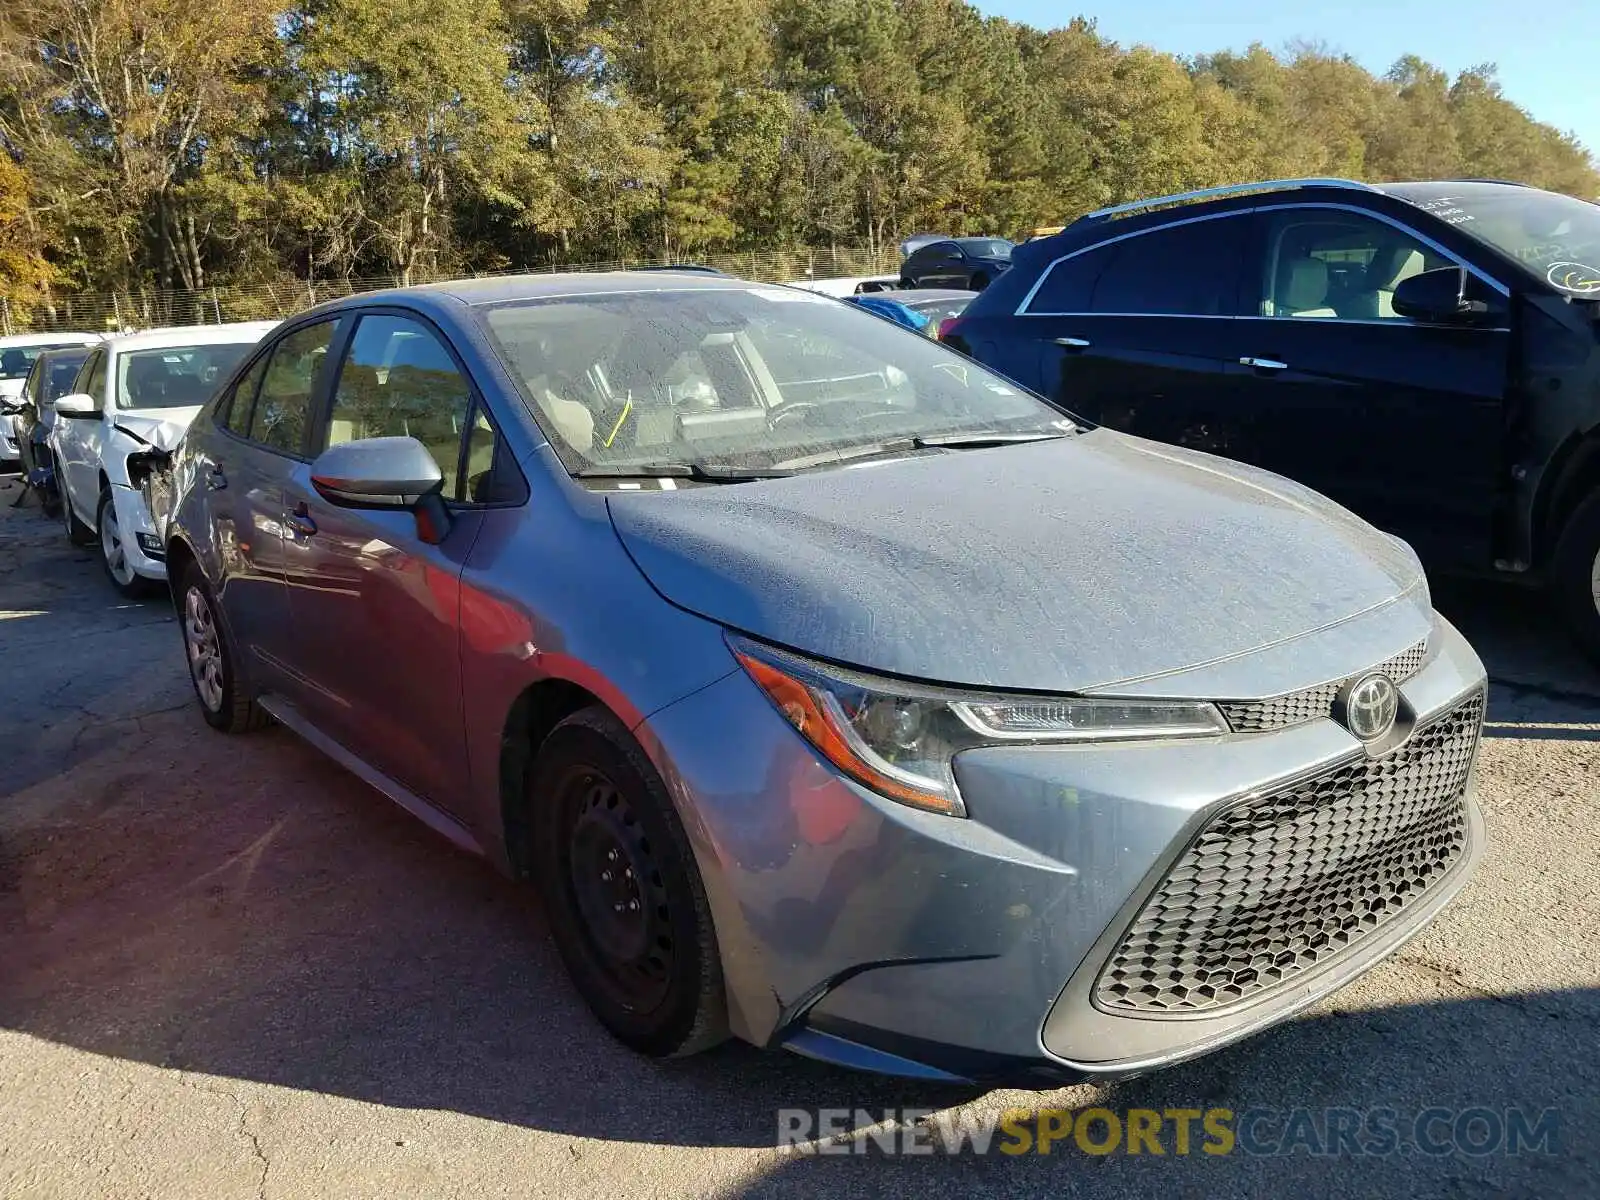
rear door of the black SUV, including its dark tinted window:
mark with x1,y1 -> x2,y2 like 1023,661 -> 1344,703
1019,214 -> 1250,454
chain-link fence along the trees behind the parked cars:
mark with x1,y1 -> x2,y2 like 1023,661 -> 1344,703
0,246 -> 899,334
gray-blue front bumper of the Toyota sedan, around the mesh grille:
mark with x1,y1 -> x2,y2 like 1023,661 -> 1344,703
640,621 -> 1485,1085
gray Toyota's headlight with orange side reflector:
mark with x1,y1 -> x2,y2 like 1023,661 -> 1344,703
728,634 -> 1227,816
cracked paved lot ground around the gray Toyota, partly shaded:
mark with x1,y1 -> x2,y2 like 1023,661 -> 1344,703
0,473 -> 1600,1200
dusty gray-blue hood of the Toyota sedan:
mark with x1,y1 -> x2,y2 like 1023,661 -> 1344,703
608,430 -> 1426,691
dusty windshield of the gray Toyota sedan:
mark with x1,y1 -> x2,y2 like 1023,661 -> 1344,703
483,288 -> 1074,474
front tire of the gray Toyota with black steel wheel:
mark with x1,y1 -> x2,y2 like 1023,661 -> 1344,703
528,707 -> 728,1058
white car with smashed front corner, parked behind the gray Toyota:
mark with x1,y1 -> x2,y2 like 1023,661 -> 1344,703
50,322 -> 274,595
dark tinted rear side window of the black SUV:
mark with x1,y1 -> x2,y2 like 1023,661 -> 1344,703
1027,216 -> 1248,317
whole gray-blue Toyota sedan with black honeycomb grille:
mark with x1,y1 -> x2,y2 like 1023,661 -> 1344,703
157,272 -> 1485,1083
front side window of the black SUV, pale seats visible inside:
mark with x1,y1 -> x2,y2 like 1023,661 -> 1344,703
1258,208 -> 1454,322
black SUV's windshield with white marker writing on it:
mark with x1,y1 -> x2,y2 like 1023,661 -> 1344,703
1397,184 -> 1600,298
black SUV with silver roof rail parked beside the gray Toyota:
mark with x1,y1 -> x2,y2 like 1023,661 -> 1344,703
944,179 -> 1600,658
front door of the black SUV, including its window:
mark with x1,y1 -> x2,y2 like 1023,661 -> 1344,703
1237,205 -> 1510,566
